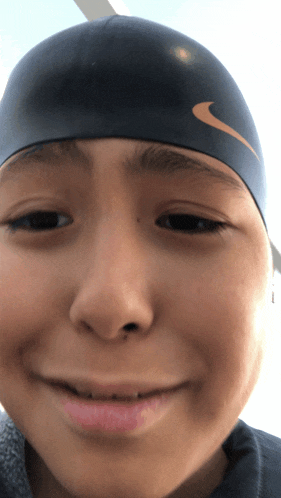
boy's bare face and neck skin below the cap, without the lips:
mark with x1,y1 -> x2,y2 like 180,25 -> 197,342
0,138 -> 272,498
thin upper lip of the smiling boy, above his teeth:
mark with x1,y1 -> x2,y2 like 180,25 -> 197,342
42,377 -> 184,396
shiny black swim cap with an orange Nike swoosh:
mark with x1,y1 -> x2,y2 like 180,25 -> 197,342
0,15 -> 267,230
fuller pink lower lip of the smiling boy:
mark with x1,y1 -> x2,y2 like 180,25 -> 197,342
53,388 -> 176,432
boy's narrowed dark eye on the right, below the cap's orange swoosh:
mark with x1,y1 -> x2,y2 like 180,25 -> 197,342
157,214 -> 227,235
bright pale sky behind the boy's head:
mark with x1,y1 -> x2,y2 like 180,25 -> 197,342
0,0 -> 281,437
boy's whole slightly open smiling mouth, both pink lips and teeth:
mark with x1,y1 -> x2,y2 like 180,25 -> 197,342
41,377 -> 189,434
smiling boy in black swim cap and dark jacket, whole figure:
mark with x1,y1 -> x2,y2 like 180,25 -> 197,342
0,16 -> 281,498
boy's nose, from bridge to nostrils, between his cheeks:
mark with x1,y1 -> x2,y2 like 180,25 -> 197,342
70,219 -> 153,341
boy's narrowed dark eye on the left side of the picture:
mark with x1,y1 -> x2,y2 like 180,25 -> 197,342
7,211 -> 69,232
